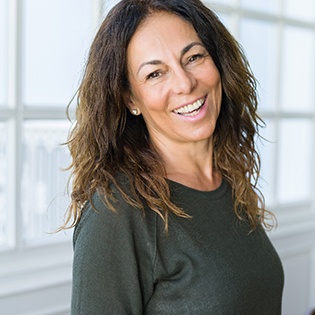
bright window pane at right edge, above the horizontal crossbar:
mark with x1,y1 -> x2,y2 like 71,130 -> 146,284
280,26 -> 315,112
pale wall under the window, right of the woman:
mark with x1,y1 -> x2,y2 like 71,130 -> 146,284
271,209 -> 315,315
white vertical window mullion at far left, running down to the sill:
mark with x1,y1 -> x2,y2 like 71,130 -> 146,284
7,0 -> 23,249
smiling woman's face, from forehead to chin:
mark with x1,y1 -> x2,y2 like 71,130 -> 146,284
127,13 -> 222,149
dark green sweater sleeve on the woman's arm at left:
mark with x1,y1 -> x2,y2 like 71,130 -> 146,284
71,195 -> 155,315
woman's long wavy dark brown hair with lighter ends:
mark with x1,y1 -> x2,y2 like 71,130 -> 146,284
65,0 -> 276,229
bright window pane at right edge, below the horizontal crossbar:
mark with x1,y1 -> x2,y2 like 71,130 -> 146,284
277,119 -> 314,203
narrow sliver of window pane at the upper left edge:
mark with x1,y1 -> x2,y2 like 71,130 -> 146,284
0,0 -> 8,106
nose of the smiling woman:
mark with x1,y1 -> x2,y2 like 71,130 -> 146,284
172,67 -> 196,94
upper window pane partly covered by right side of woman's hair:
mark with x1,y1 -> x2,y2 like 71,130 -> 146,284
241,19 -> 277,110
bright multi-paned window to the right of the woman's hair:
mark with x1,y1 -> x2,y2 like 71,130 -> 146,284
205,0 -> 315,215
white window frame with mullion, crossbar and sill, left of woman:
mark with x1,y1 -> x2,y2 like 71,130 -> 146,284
0,0 -> 104,303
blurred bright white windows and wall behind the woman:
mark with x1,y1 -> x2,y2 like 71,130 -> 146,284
0,0 -> 315,315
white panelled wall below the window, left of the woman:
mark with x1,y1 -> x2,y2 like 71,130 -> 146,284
0,242 -> 72,315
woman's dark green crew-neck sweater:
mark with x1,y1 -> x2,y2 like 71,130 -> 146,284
72,181 -> 283,315
